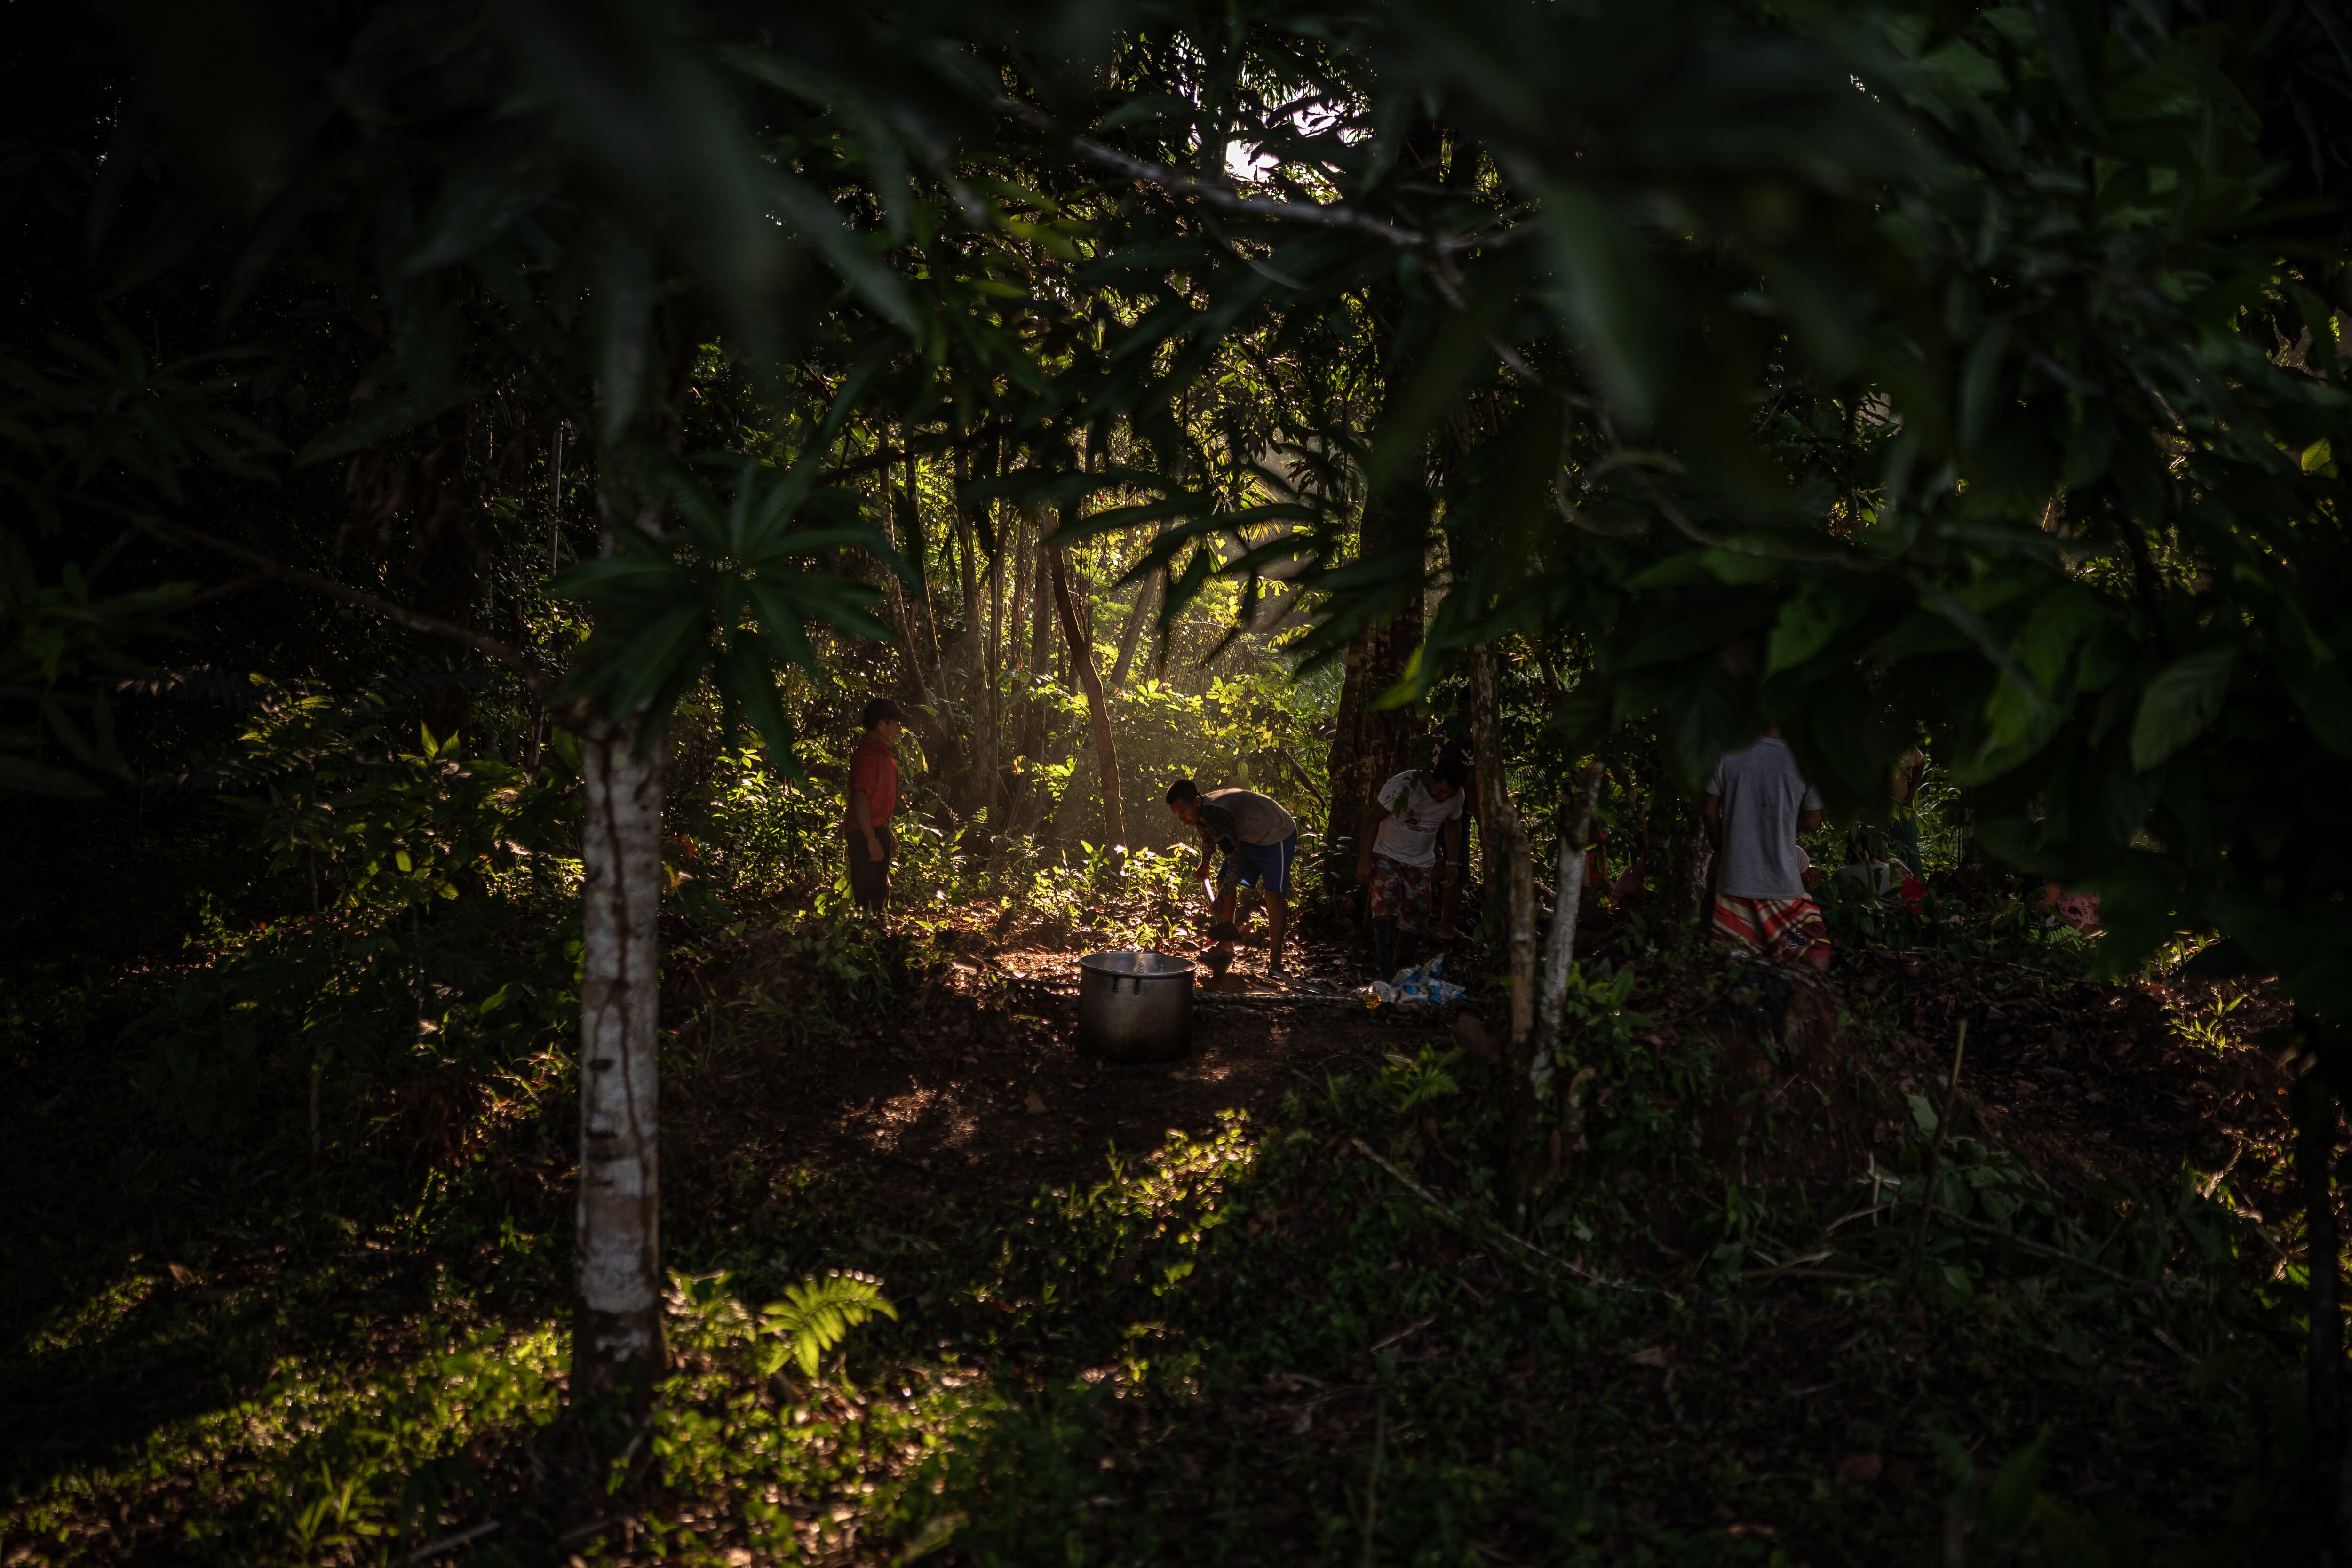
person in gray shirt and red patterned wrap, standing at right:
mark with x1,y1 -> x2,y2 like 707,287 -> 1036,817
1700,729 -> 1830,969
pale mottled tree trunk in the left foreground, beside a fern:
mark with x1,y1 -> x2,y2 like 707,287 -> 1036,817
572,722 -> 663,1403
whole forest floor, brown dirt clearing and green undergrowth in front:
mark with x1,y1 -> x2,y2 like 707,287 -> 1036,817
0,883 -> 2300,1566
